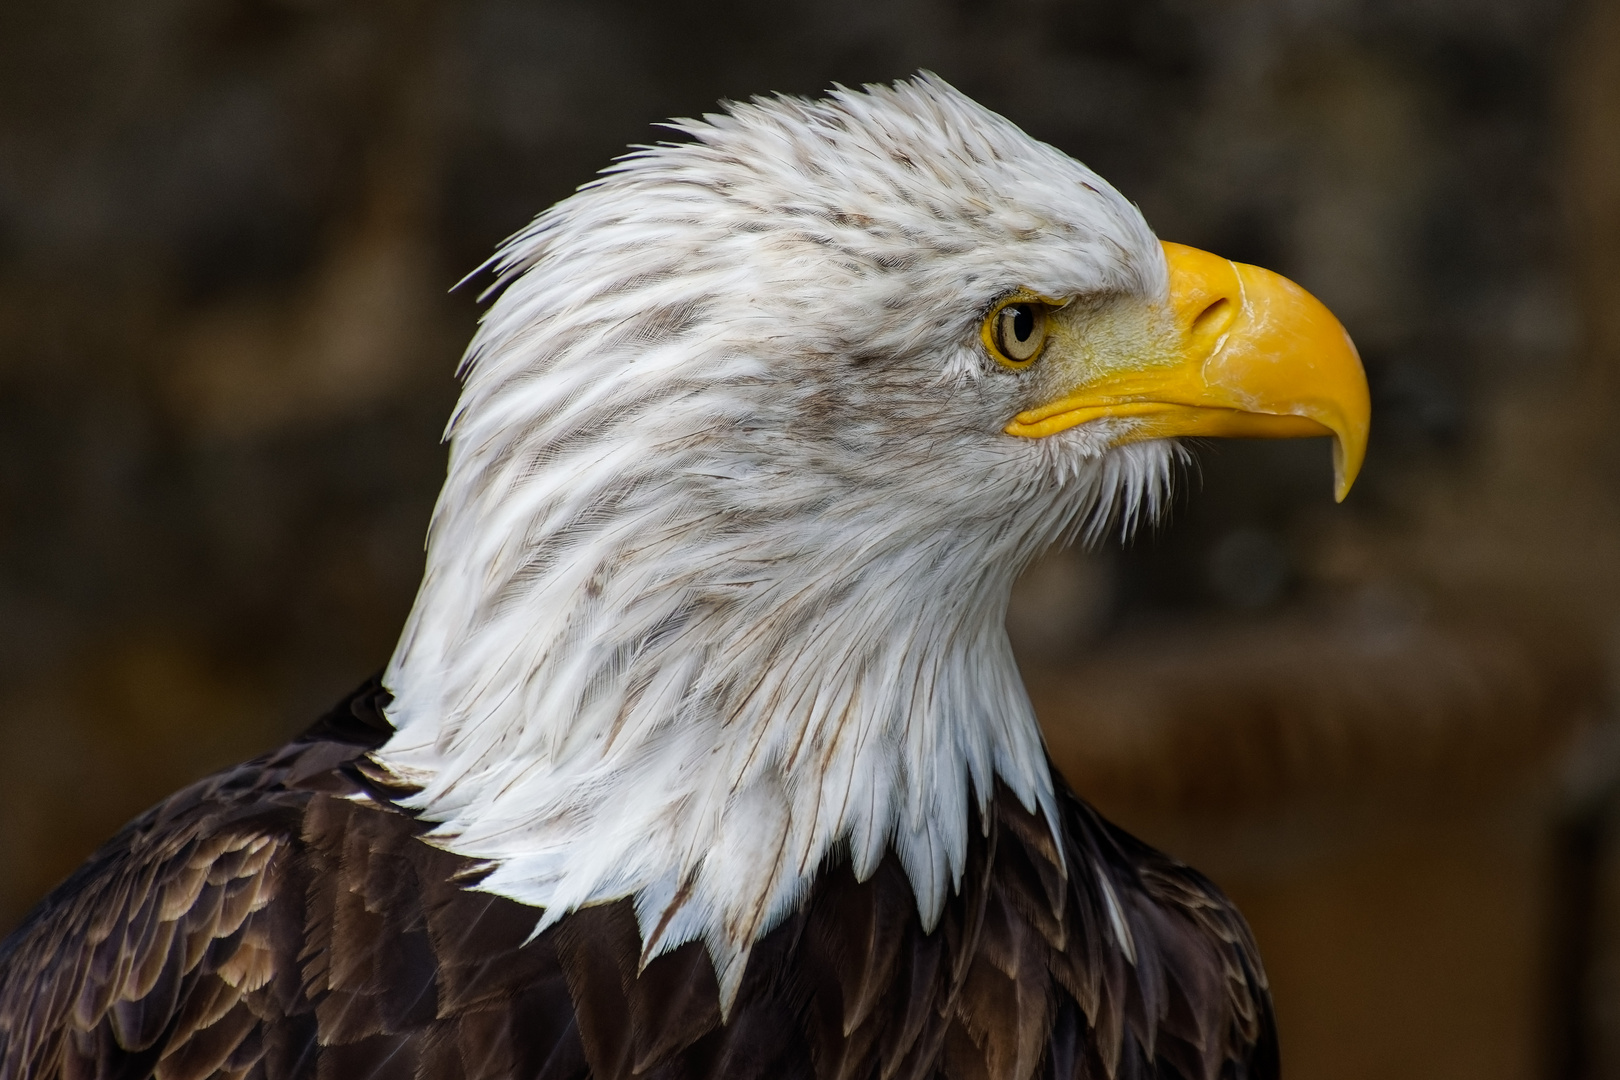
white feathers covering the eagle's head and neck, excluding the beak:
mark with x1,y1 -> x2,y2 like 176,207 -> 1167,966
376,76 -> 1173,1002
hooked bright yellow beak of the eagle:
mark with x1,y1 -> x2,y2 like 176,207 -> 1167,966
1006,243 -> 1371,500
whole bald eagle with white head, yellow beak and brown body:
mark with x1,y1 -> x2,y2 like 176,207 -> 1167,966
0,76 -> 1367,1080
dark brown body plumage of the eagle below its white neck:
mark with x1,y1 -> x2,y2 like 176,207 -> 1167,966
0,683 -> 1277,1080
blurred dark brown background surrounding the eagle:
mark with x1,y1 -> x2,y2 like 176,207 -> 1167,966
0,0 -> 1620,1080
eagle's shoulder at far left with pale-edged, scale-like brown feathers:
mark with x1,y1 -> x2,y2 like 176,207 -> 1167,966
0,685 -> 382,1080
